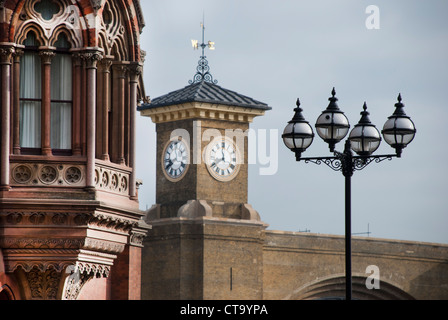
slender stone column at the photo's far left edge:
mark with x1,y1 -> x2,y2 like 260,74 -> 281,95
0,45 -> 14,190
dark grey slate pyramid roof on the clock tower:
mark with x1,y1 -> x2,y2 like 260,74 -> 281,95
138,81 -> 271,111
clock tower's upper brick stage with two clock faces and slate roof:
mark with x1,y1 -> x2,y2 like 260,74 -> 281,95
139,81 -> 269,219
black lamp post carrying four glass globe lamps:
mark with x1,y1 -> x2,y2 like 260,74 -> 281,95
282,88 -> 416,300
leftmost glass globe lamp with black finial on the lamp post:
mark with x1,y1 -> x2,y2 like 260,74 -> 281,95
282,99 -> 314,160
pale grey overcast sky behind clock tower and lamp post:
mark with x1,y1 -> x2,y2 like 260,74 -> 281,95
137,0 -> 448,243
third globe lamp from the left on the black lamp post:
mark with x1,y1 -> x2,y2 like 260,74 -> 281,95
349,102 -> 381,156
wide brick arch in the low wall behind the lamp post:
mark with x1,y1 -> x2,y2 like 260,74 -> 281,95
285,274 -> 415,300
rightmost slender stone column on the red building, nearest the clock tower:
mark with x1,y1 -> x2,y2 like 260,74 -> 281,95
129,62 -> 143,199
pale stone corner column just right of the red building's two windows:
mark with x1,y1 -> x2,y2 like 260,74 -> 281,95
83,49 -> 102,189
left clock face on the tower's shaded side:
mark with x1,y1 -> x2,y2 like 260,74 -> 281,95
162,140 -> 188,181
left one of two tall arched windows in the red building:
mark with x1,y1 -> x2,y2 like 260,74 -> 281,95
20,31 -> 42,153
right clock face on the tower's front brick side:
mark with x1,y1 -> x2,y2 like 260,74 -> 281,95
206,139 -> 239,181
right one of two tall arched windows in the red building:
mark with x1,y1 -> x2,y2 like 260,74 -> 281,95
51,33 -> 72,154
